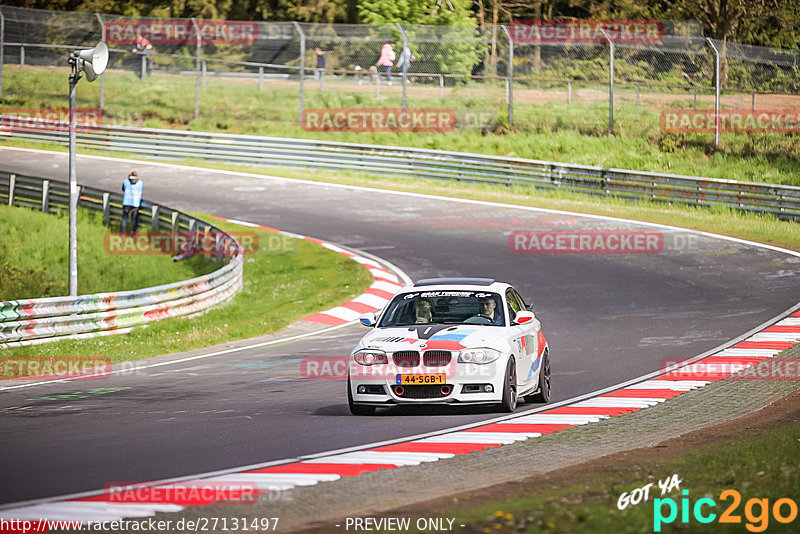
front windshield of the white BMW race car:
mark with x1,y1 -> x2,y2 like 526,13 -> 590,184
378,291 -> 506,327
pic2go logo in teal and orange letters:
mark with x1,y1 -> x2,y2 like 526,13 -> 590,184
653,489 -> 797,532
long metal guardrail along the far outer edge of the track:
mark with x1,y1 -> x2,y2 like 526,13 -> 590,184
0,116 -> 800,219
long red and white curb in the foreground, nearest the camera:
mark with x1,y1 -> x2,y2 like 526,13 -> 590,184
0,308 -> 800,521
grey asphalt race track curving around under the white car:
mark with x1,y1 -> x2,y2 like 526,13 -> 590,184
0,149 -> 800,504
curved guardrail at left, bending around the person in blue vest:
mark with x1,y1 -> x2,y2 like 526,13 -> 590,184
0,171 -> 244,348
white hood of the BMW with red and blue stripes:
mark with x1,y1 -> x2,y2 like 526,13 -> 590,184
356,324 -> 506,352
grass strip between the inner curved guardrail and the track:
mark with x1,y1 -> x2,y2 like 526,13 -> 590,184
0,210 -> 372,363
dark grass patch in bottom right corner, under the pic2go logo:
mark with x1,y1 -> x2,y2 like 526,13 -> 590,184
444,422 -> 800,533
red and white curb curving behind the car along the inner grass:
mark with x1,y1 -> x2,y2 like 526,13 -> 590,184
211,215 -> 409,326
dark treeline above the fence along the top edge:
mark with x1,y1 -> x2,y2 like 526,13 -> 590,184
2,0 -> 800,49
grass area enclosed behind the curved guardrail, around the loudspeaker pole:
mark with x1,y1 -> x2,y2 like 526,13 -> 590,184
0,205 -> 219,300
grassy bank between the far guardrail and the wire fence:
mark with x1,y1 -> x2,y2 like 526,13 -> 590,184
2,68 -> 800,185
